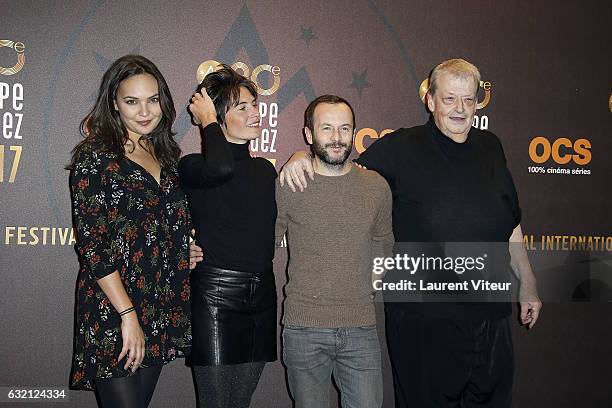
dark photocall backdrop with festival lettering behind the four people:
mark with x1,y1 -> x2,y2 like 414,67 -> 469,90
0,0 -> 612,408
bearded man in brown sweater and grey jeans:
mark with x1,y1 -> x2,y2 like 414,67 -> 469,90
276,95 -> 394,408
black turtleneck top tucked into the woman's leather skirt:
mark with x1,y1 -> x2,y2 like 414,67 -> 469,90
179,123 -> 276,272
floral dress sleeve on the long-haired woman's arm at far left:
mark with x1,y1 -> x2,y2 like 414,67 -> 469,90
70,153 -> 121,279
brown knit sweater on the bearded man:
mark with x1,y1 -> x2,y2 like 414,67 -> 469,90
276,164 -> 393,327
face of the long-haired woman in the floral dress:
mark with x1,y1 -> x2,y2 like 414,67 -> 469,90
115,74 -> 162,139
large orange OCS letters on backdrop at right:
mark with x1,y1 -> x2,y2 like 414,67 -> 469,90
529,136 -> 591,166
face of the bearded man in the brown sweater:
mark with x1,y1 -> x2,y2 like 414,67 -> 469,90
304,103 -> 354,168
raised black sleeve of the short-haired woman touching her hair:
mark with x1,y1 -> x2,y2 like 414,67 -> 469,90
179,122 -> 234,188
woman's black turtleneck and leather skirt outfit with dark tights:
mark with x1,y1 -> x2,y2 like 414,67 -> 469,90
179,123 -> 277,407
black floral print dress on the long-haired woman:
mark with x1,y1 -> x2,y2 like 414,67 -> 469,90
70,147 -> 191,390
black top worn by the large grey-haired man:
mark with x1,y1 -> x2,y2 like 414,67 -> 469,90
357,119 -> 521,320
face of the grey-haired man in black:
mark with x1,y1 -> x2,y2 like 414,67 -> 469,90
427,74 -> 478,143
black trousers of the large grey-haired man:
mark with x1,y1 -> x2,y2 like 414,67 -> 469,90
385,309 -> 514,408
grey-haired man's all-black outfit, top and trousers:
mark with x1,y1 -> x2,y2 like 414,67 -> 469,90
357,119 -> 521,408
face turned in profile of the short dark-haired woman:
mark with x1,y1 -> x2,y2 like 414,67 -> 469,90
222,86 -> 261,144
